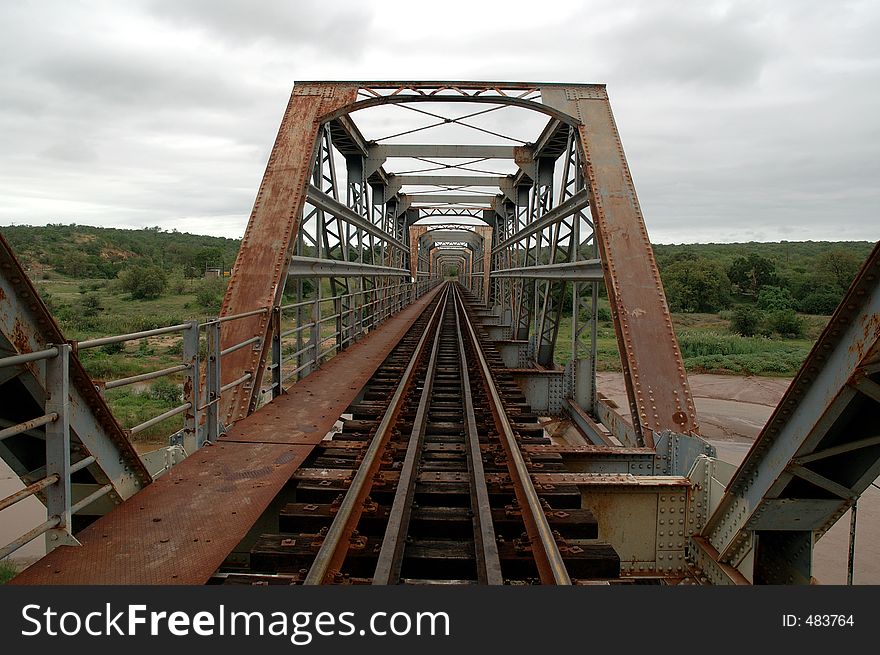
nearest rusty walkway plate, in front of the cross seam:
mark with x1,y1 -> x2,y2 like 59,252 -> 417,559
11,443 -> 310,585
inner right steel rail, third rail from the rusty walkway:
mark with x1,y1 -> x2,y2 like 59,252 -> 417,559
452,301 -> 504,585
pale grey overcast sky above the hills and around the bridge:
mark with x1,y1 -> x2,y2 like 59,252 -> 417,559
0,0 -> 880,243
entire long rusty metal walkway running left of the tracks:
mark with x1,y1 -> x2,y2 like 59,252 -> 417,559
11,290 -> 437,584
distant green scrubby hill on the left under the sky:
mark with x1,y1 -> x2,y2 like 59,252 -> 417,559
0,224 -> 241,279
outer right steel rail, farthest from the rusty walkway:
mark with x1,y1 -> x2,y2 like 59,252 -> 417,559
454,289 -> 571,585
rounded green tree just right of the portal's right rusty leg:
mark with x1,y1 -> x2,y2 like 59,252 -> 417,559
663,257 -> 730,312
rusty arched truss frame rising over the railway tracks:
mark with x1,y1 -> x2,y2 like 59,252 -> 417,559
221,82 -> 698,452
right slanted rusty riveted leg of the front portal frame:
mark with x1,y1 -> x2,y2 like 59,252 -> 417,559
574,94 -> 699,446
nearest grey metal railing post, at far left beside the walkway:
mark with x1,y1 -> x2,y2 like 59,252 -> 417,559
45,343 -> 77,550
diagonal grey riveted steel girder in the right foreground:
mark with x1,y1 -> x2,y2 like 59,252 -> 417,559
703,244 -> 880,566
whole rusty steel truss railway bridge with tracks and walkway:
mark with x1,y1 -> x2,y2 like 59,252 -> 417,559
0,82 -> 880,584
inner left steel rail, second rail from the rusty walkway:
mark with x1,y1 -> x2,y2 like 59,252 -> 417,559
373,288 -> 447,585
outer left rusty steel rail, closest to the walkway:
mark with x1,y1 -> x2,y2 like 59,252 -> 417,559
303,290 -> 444,585
